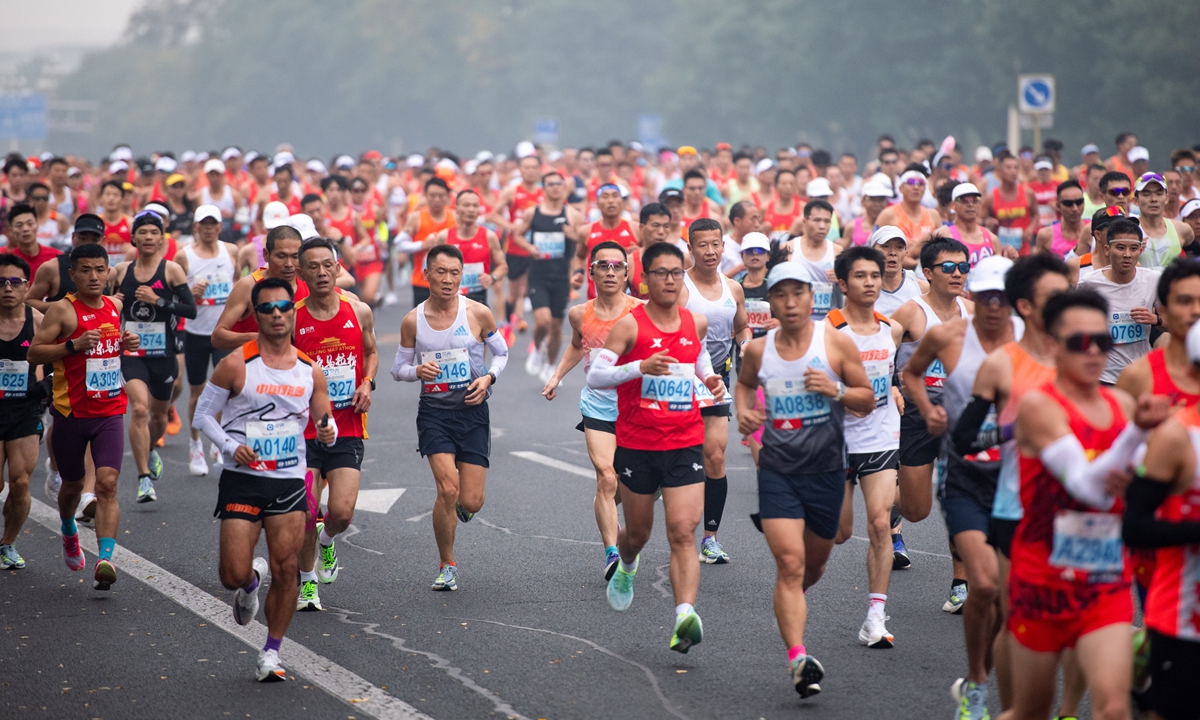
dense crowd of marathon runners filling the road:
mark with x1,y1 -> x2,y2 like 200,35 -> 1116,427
0,133 -> 1200,720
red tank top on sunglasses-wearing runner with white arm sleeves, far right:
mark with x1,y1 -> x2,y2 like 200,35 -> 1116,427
1012,382 -> 1130,590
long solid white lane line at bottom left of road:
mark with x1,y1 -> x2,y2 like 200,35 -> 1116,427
29,499 -> 432,720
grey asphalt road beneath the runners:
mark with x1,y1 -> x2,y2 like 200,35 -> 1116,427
0,294 -> 1094,720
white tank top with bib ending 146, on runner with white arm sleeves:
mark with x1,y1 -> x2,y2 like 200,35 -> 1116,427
414,295 -> 492,410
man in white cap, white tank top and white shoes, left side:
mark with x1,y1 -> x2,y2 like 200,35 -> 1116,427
175,205 -> 234,475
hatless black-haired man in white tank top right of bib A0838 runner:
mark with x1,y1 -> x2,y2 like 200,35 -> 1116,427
826,246 -> 901,648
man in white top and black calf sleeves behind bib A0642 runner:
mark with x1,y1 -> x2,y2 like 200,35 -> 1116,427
677,217 -> 751,565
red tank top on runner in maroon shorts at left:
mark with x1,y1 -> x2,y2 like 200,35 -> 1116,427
54,293 -> 126,418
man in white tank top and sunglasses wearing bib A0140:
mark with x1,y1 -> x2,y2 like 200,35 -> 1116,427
196,277 -> 337,683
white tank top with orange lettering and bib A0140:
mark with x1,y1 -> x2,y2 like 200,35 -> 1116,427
222,341 -> 312,480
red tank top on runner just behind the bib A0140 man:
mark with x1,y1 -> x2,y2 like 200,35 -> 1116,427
295,296 -> 367,440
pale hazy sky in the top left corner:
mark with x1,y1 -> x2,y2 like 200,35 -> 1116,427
0,0 -> 144,53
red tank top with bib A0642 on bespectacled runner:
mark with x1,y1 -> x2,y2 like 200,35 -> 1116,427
617,305 -> 704,450
